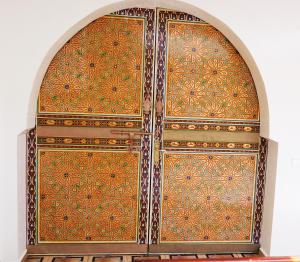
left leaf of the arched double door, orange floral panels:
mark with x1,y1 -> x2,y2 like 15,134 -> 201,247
29,9 -> 154,253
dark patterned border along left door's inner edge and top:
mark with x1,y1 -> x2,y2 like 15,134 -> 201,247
114,8 -> 155,244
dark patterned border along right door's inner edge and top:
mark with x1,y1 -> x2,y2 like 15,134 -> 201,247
150,9 -> 205,244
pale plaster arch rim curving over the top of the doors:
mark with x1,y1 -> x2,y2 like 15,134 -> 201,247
27,0 -> 269,138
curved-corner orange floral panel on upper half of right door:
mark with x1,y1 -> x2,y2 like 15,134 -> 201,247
165,20 -> 259,120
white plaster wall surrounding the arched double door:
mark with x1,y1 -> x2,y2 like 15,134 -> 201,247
0,0 -> 300,262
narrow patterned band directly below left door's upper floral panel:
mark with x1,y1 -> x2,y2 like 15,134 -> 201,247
37,118 -> 142,129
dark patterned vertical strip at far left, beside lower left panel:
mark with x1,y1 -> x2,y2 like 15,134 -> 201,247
26,128 -> 36,245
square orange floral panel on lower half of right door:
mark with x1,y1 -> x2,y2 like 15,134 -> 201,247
160,153 -> 257,243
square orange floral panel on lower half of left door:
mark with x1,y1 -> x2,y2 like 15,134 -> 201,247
38,150 -> 140,242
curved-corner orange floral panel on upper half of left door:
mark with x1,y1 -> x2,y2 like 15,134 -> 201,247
39,16 -> 144,116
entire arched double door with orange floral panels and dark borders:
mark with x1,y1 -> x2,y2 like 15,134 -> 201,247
28,8 -> 264,253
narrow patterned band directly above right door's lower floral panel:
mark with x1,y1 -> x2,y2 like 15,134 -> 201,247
164,140 -> 259,151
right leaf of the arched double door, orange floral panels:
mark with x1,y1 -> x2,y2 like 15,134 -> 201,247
150,10 -> 259,252
